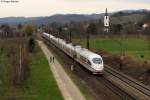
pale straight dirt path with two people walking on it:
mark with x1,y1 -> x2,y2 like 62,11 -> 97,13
38,41 -> 85,100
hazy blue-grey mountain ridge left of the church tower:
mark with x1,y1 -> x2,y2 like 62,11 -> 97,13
0,14 -> 102,24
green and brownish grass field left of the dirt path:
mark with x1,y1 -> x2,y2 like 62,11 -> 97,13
0,39 -> 63,100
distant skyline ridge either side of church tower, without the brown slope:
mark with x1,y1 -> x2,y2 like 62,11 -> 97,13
0,9 -> 150,24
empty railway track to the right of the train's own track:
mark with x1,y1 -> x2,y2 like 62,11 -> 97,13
105,65 -> 150,100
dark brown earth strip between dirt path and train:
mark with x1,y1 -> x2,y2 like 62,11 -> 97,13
45,40 -> 122,100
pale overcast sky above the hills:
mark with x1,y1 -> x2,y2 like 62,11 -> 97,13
0,0 -> 150,18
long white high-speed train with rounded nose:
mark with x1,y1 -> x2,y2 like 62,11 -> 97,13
42,33 -> 104,74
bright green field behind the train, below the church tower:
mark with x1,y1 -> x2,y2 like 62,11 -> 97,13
74,37 -> 150,59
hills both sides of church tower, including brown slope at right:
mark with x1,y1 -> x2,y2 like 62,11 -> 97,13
0,9 -> 150,24
